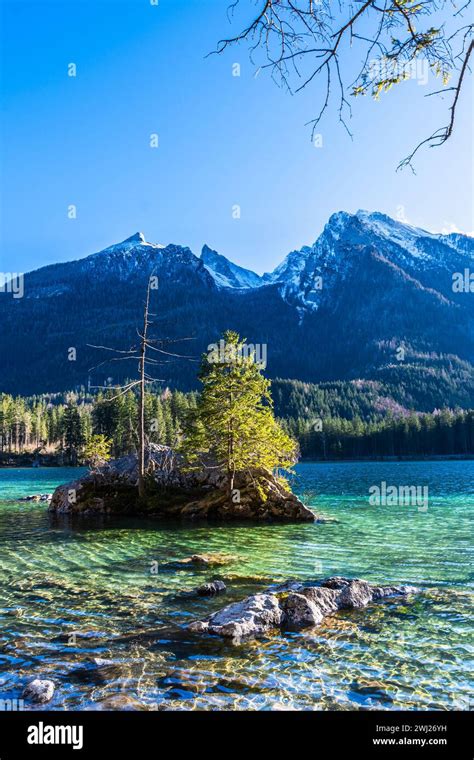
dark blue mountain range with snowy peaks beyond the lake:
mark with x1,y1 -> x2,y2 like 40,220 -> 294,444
0,211 -> 474,411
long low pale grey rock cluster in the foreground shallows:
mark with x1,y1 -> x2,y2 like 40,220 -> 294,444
188,576 -> 418,641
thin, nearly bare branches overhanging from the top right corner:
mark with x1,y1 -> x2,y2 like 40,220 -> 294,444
214,0 -> 474,170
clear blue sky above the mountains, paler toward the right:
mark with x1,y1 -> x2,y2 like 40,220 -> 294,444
0,0 -> 474,273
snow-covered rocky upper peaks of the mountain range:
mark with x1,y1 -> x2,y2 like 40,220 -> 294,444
71,209 -> 474,311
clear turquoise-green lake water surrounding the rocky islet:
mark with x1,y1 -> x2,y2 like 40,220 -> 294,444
0,462 -> 474,710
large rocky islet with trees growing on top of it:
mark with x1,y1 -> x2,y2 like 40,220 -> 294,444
49,444 -> 316,522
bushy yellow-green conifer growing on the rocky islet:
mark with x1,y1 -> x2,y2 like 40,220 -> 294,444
181,331 -> 297,498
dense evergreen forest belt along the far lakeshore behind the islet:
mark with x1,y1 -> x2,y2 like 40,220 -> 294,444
0,380 -> 474,464
